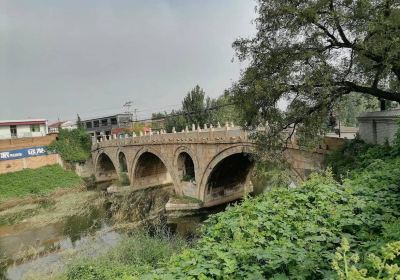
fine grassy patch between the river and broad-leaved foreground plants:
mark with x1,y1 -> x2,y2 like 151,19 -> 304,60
66,231 -> 186,280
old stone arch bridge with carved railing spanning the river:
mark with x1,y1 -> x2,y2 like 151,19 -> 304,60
92,126 -> 325,207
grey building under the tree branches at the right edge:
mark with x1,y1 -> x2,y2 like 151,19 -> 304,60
358,109 -> 400,145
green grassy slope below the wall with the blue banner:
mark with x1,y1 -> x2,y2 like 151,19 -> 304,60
0,165 -> 82,201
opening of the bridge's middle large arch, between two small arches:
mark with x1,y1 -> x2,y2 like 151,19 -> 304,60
133,152 -> 172,188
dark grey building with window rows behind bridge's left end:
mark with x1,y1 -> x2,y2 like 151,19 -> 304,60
82,114 -> 132,138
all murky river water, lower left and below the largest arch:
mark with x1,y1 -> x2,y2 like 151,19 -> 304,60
0,198 -> 228,280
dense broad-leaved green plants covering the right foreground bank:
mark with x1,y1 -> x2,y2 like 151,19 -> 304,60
57,137 -> 400,280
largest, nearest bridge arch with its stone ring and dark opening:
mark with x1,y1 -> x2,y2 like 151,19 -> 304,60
198,145 -> 254,206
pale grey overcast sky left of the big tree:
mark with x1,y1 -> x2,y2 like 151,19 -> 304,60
0,0 -> 256,121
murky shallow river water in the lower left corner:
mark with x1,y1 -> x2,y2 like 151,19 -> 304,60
0,205 -> 111,280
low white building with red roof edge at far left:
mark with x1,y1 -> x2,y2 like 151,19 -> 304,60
0,119 -> 47,139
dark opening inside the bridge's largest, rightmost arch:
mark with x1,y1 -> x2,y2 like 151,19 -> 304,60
205,153 -> 254,201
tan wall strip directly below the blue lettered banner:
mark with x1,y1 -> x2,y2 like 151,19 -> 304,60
0,154 -> 62,174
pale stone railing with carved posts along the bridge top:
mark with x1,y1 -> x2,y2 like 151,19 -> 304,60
92,123 -> 251,149
